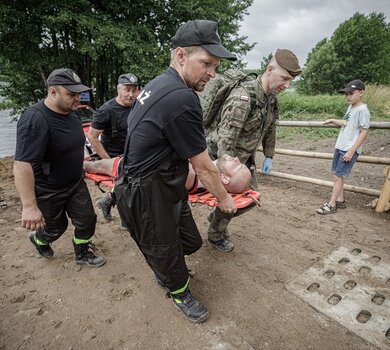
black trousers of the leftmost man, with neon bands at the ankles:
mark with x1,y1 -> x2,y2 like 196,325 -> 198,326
35,178 -> 96,243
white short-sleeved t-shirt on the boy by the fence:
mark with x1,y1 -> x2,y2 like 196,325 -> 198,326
335,104 -> 370,154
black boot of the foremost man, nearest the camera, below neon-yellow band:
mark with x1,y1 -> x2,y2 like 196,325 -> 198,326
171,288 -> 209,323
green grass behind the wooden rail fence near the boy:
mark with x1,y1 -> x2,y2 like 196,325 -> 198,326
276,85 -> 390,141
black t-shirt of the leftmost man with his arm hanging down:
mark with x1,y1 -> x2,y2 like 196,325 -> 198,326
15,100 -> 85,186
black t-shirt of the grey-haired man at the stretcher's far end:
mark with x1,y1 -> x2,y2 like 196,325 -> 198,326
91,98 -> 132,157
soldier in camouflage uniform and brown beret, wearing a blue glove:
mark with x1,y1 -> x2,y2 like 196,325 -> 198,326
206,49 -> 302,252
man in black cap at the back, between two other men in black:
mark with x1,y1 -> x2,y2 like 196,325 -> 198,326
88,73 -> 139,159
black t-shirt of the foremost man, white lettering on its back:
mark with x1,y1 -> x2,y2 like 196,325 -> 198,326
124,67 -> 207,176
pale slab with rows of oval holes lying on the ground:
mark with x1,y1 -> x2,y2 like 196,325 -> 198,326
286,245 -> 390,349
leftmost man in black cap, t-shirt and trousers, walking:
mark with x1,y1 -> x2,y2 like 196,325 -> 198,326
14,68 -> 106,267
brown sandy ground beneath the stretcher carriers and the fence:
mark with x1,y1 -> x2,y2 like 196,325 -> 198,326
0,131 -> 390,350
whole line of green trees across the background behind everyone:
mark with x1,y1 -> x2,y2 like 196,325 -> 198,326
0,0 -> 390,115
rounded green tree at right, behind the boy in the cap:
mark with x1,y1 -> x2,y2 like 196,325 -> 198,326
298,13 -> 390,94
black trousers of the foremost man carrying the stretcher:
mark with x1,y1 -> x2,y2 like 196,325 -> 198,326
115,163 -> 202,292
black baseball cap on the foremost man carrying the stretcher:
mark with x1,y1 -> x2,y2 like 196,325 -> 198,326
171,19 -> 237,61
